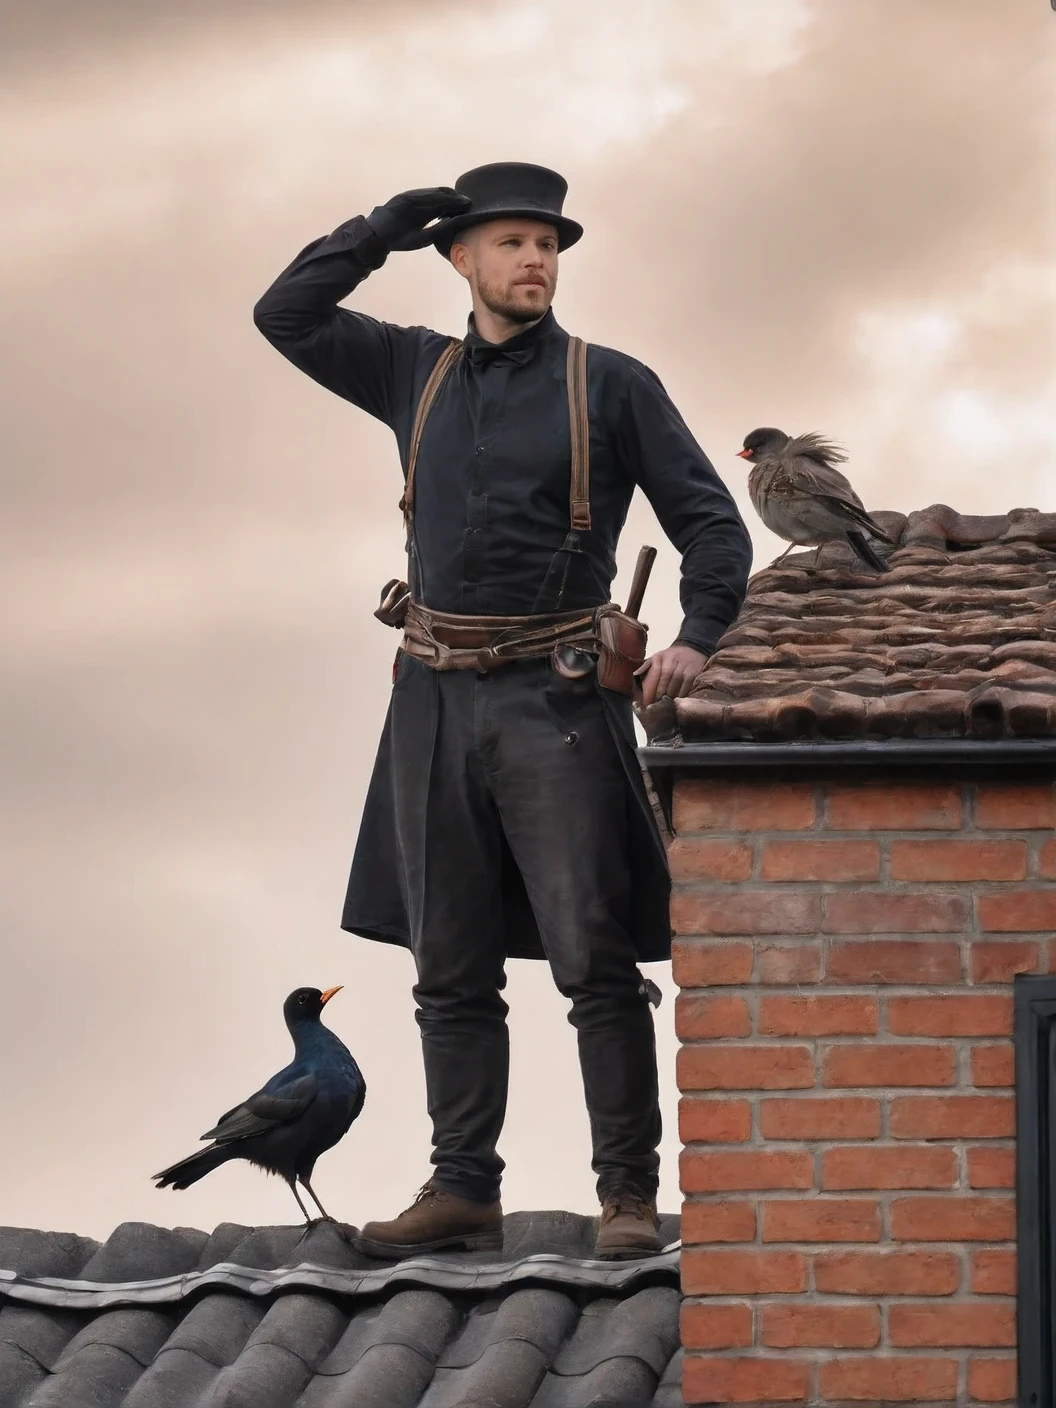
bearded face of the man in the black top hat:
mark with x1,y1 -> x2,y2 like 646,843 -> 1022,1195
451,220 -> 558,322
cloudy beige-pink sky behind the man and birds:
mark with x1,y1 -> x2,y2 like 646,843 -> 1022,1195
0,0 -> 1056,1236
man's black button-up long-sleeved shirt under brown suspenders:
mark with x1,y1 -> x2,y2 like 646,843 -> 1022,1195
253,215 -> 752,653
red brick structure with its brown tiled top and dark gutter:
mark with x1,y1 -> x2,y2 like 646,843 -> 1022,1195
643,510 -> 1056,1408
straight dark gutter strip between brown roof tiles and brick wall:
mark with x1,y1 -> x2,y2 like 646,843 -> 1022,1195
639,738 -> 1056,774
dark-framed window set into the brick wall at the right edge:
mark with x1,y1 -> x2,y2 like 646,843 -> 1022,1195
1015,976 -> 1056,1408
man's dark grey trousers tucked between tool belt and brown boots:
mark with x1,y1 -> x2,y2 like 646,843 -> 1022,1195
391,656 -> 660,1202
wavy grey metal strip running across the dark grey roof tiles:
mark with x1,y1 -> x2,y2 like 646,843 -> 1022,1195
0,1242 -> 680,1311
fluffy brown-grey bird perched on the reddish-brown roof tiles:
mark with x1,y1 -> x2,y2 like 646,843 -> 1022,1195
736,425 -> 893,572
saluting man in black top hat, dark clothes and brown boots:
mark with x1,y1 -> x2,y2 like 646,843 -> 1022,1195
255,163 -> 750,1257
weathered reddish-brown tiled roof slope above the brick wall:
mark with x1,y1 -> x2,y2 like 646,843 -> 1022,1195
676,504 -> 1056,743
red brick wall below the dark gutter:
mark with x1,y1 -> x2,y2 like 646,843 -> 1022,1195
672,773 -> 1056,1405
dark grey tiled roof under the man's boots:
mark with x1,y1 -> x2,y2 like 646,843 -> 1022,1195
0,1212 -> 681,1408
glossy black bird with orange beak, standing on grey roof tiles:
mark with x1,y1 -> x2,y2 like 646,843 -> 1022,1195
153,987 -> 366,1228
